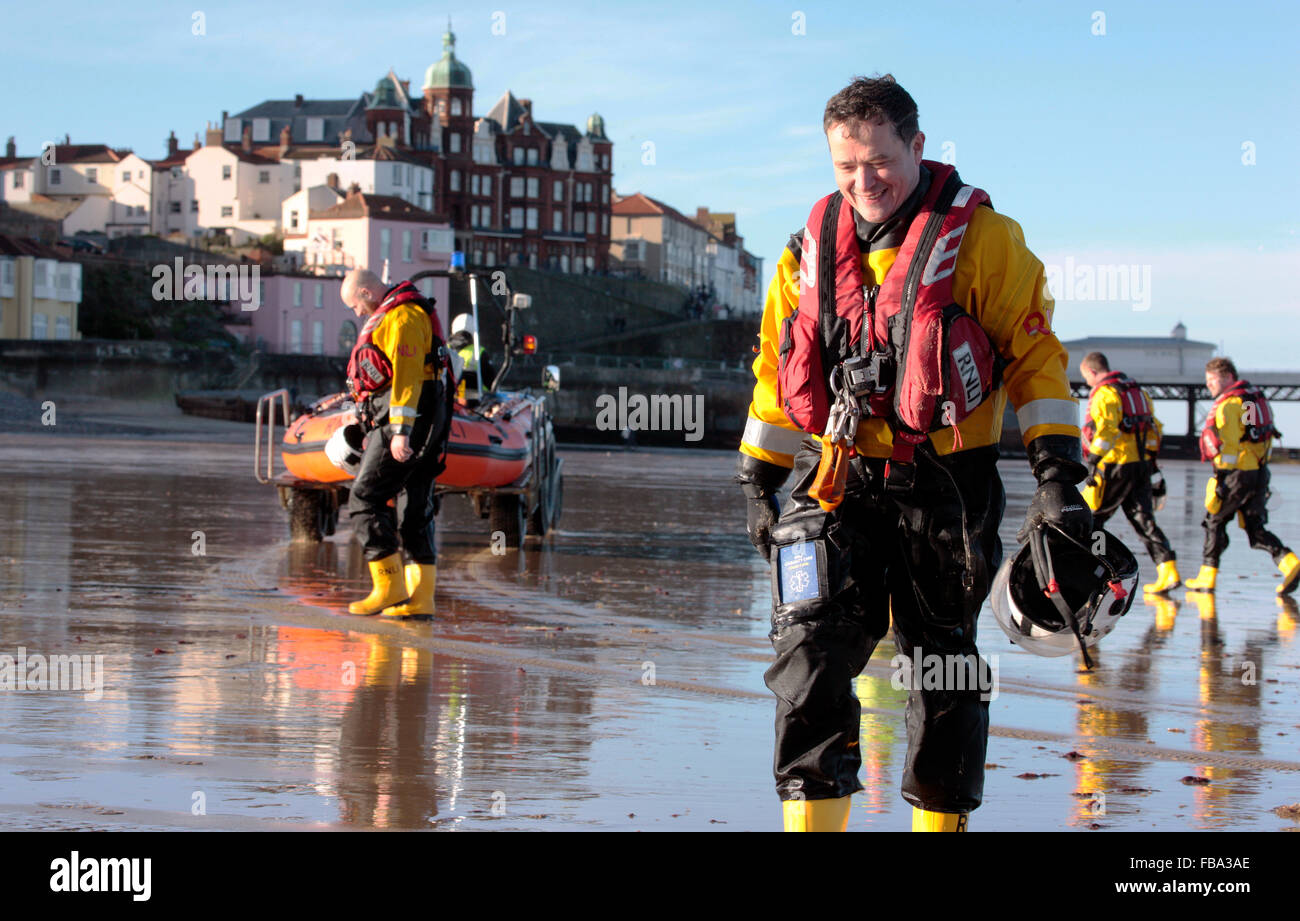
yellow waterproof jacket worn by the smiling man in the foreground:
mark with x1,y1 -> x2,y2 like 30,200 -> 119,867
740,206 -> 1080,468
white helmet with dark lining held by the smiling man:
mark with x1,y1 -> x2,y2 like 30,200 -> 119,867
991,526 -> 1138,669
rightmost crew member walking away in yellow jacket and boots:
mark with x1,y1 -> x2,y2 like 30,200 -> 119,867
1187,358 -> 1300,594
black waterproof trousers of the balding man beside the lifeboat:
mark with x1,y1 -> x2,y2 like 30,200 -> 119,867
347,380 -> 451,563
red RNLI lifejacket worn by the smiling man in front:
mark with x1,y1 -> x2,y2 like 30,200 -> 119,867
777,160 -> 1001,463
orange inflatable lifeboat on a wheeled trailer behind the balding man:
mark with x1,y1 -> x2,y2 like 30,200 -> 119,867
281,394 -> 533,489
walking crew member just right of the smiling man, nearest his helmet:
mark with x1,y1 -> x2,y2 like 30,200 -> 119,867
1079,351 -> 1182,594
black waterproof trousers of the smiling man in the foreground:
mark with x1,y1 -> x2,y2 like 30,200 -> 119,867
764,442 -> 1006,813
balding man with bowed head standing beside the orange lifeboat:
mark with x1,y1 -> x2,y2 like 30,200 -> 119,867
341,269 -> 451,617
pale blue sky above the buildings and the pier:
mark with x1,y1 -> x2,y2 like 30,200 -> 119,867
10,0 -> 1300,369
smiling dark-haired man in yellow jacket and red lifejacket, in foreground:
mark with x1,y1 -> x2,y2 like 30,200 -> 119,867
737,75 -> 1092,831
